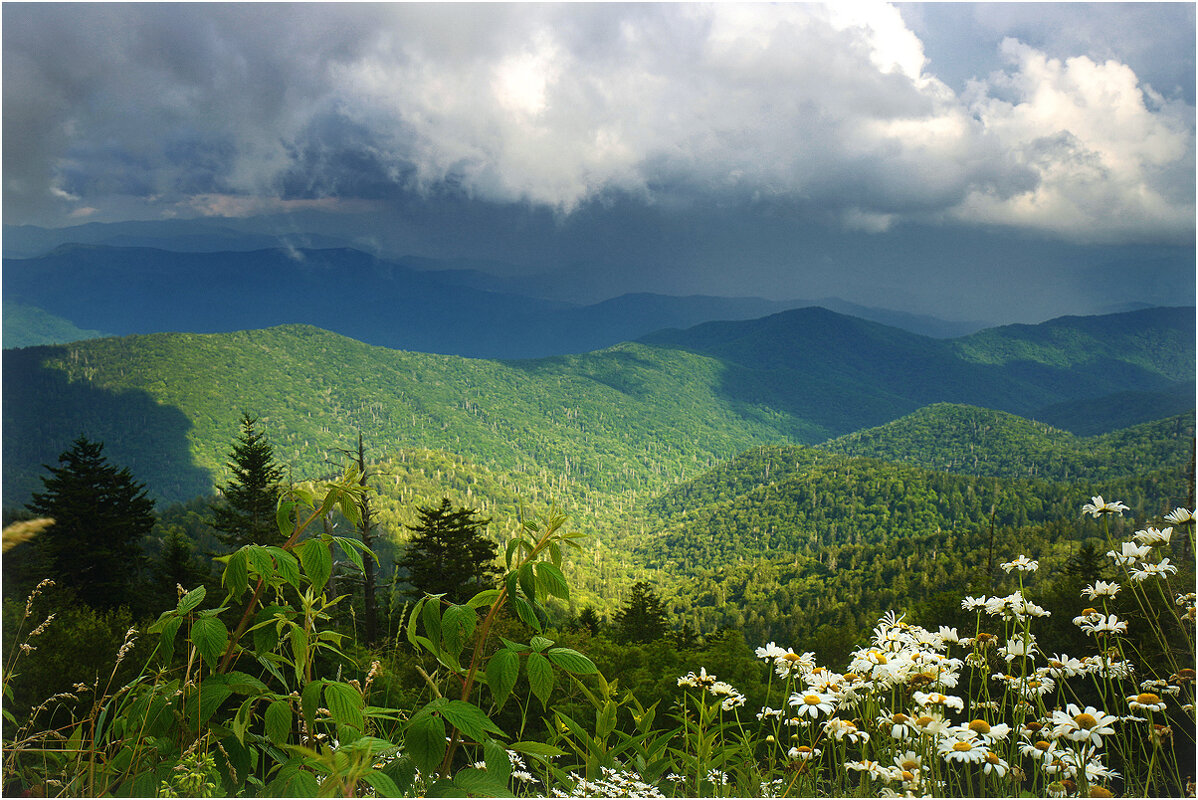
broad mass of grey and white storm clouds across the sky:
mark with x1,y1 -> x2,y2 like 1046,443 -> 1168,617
4,4 -> 1194,244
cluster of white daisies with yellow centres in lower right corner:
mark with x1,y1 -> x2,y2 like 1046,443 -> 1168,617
737,497 -> 1196,796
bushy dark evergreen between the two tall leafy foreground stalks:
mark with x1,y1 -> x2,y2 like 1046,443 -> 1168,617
395,498 -> 500,604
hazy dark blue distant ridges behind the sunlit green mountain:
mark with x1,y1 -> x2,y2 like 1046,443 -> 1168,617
4,223 -> 984,358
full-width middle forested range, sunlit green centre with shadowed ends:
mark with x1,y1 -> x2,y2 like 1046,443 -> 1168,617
4,302 -> 1194,510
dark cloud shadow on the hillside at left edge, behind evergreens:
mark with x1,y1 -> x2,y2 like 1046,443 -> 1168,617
4,345 -> 212,508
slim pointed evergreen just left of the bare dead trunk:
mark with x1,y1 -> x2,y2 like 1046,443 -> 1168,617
212,414 -> 283,550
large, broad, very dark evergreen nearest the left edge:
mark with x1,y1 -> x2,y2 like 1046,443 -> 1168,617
29,436 -> 155,608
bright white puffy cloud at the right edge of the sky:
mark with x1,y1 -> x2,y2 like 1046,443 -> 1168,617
954,40 -> 1194,241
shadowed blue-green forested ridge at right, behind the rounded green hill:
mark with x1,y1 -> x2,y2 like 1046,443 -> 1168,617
642,302 -> 1194,435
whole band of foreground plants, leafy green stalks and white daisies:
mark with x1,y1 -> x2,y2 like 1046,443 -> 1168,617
4,471 -> 1194,796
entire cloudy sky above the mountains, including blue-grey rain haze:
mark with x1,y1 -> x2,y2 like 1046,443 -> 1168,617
2,2 -> 1196,322
